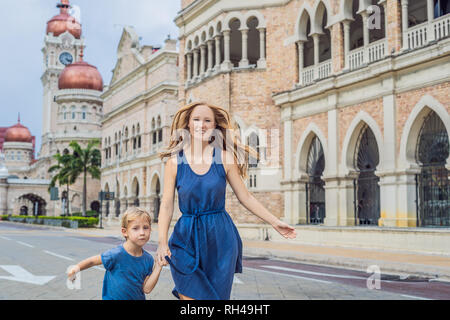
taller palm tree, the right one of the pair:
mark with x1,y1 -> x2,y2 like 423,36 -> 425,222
69,139 -> 101,217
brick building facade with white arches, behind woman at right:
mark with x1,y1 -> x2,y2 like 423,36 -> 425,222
175,0 -> 450,227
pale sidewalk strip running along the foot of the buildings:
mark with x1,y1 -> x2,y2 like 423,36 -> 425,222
65,224 -> 450,281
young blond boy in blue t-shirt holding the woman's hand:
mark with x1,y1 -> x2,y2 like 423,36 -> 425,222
68,208 -> 162,300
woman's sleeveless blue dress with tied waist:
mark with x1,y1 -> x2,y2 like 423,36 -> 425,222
166,148 -> 242,300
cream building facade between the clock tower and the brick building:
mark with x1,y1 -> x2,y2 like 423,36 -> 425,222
101,27 -> 179,223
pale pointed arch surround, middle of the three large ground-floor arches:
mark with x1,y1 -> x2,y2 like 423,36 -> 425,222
341,111 -> 384,175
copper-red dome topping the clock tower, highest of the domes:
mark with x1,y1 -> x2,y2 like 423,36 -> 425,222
46,0 -> 81,39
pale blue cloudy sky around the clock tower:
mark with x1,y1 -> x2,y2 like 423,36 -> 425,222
0,0 -> 181,153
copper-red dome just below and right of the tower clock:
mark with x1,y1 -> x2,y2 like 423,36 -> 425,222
58,60 -> 103,91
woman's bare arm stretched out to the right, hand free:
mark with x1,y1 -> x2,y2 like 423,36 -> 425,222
222,151 -> 297,239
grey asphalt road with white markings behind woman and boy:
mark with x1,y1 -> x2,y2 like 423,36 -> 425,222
0,222 -> 450,300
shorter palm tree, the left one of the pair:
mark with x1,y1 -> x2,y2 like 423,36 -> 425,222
48,152 -> 76,215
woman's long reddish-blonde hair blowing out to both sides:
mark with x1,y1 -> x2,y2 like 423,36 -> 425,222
159,102 -> 259,178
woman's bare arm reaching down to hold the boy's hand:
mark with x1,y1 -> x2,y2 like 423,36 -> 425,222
156,156 -> 177,266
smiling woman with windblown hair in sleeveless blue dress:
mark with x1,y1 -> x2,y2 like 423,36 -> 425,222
157,102 -> 296,300
